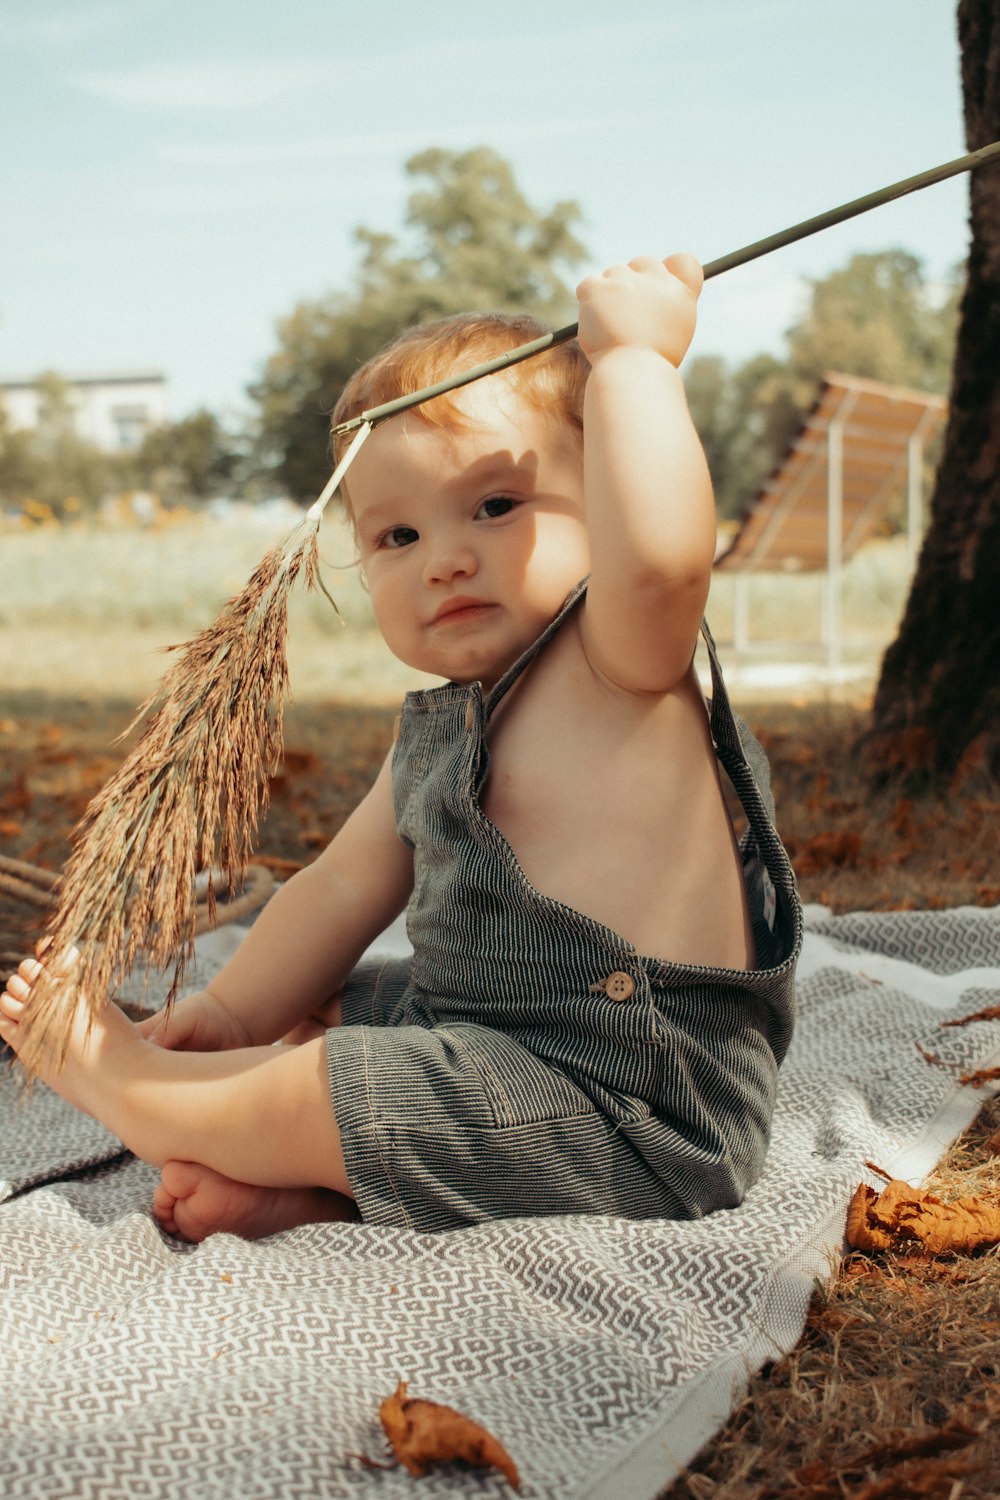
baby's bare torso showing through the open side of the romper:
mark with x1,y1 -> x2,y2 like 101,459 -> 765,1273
483,615 -> 754,969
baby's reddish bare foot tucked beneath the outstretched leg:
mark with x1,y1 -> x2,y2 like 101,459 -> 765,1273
153,1161 -> 358,1244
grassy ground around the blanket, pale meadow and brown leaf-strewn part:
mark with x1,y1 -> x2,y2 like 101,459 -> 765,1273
0,518 -> 1000,1500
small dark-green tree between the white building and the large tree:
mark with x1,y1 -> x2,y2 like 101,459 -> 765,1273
123,410 -> 240,504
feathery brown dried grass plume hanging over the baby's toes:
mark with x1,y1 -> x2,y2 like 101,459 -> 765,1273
13,426 -> 370,1074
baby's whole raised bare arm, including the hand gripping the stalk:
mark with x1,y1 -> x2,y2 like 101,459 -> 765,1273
577,255 -> 715,693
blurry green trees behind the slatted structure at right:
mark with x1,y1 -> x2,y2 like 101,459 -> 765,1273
685,249 -> 961,516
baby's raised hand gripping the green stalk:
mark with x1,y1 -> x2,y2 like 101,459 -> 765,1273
576,255 -> 705,366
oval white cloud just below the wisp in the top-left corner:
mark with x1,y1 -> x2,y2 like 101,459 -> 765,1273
67,59 -> 324,114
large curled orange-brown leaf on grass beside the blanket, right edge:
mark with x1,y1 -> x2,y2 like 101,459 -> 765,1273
847,1179 -> 1000,1256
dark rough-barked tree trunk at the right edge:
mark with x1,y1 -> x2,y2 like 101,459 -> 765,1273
868,0 -> 1000,785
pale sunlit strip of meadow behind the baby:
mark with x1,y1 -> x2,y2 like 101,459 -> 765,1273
0,510 -> 907,704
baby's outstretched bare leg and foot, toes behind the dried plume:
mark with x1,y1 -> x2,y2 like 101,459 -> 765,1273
0,960 -> 351,1218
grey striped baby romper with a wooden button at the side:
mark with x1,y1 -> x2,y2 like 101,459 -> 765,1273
327,584 -> 802,1230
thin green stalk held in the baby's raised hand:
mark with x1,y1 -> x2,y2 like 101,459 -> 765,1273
332,141 -> 1000,438
